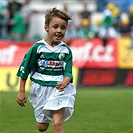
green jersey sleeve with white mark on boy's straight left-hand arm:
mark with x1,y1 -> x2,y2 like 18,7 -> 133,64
17,46 -> 37,80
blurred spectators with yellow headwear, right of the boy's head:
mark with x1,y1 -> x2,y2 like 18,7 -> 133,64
65,3 -> 133,45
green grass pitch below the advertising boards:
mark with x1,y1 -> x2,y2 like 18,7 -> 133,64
0,88 -> 133,133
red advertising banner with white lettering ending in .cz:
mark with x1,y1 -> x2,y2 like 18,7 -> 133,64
70,38 -> 118,68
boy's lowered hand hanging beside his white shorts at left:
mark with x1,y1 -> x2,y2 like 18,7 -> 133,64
16,91 -> 27,107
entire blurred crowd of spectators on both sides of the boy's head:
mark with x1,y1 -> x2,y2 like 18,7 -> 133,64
0,0 -> 133,45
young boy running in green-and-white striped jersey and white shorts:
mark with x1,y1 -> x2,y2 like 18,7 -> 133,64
17,8 -> 76,133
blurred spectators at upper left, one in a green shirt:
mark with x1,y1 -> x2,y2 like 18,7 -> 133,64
0,0 -> 35,41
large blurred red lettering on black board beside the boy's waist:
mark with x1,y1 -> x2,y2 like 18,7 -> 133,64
81,69 -> 116,86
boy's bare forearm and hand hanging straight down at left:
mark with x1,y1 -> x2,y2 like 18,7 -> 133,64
16,78 -> 26,107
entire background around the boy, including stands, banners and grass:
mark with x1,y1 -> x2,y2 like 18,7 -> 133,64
0,0 -> 133,133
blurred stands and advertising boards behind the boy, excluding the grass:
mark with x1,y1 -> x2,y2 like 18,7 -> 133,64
0,0 -> 133,90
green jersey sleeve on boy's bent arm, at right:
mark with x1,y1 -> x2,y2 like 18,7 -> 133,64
64,49 -> 73,80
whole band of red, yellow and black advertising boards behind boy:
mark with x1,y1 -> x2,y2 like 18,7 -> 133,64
0,38 -> 133,91
